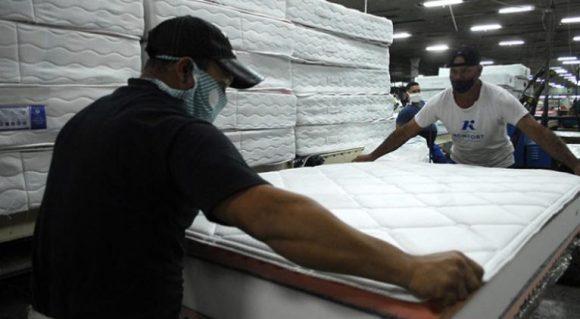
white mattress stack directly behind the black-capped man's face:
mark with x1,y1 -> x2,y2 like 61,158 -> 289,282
145,0 -> 296,166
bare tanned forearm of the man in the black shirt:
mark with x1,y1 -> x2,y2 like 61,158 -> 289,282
240,190 -> 414,287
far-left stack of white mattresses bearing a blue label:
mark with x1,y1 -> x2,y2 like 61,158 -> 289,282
0,0 -> 143,215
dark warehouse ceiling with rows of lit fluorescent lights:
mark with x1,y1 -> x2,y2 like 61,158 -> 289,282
330,0 -> 580,83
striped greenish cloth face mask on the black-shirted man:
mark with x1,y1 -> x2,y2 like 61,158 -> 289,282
151,56 -> 227,123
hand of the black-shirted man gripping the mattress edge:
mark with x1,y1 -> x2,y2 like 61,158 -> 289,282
408,252 -> 483,306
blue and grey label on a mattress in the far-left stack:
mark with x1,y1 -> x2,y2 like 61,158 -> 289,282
0,105 -> 46,131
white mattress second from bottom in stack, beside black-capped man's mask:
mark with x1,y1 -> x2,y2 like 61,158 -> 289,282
214,90 -> 296,130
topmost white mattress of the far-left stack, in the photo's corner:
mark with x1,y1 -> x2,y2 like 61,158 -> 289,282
0,0 -> 144,38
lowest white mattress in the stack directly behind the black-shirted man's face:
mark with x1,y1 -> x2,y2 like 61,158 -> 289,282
224,128 -> 296,166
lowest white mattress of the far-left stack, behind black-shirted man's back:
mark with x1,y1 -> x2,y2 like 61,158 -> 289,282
0,151 -> 52,215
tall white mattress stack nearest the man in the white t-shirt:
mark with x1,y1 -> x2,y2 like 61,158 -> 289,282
286,0 -> 394,156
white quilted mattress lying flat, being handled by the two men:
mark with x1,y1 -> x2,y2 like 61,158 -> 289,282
184,161 -> 580,318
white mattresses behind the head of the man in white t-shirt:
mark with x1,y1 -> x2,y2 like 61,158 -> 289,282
415,64 -> 530,99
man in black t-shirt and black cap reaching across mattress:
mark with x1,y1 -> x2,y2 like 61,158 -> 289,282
31,16 -> 482,319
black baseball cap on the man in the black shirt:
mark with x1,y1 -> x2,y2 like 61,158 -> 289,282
145,16 -> 264,89
